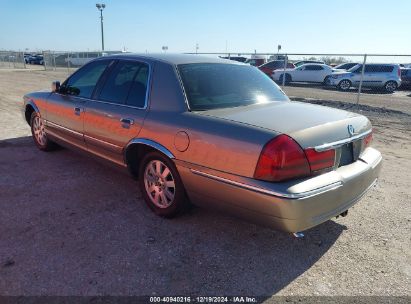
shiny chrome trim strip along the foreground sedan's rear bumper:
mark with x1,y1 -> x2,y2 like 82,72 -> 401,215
190,169 -> 343,199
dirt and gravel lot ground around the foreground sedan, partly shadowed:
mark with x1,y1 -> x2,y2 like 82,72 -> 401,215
0,70 -> 411,297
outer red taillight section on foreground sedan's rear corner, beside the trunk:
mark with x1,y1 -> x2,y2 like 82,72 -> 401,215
254,135 -> 310,182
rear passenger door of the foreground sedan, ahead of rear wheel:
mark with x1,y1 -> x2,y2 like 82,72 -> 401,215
84,60 -> 151,165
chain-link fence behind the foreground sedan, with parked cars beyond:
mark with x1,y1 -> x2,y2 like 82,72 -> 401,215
0,51 -> 411,114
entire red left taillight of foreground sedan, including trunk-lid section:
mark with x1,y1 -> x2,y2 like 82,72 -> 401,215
254,135 -> 335,182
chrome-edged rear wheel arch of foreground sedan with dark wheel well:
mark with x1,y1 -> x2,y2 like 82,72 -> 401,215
124,138 -> 175,178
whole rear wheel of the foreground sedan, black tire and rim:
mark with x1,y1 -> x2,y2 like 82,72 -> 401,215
138,152 -> 188,218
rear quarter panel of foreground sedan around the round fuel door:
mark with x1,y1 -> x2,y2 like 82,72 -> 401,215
140,111 -> 277,177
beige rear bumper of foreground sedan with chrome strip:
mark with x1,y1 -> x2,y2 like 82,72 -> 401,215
176,148 -> 382,232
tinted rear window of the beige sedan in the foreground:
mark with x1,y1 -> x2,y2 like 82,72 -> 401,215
178,63 -> 289,111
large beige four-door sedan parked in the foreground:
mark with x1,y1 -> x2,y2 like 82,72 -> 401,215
23,54 -> 382,233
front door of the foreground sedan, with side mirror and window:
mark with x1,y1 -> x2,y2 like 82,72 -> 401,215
46,60 -> 110,149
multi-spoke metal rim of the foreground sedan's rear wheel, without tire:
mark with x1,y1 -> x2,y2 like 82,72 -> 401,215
144,160 -> 176,208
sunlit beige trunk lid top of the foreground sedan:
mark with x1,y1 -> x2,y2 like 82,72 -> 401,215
198,101 -> 371,148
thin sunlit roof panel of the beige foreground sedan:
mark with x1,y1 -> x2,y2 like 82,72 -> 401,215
99,53 -> 244,65
